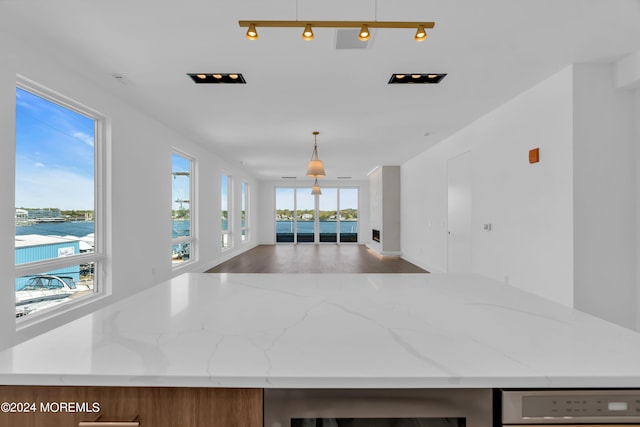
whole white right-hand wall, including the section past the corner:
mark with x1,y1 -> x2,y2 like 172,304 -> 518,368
402,64 -> 640,329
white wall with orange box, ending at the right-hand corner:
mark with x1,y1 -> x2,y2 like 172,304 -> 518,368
401,67 -> 573,305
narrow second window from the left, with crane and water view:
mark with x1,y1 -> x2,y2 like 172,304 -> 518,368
171,152 -> 195,267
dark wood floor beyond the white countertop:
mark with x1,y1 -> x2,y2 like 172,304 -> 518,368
207,245 -> 428,273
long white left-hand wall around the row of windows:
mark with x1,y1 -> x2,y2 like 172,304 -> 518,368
0,34 -> 258,348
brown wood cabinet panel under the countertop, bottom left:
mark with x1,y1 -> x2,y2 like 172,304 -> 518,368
0,386 -> 262,427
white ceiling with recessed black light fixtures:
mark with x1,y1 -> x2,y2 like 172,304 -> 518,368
0,0 -> 640,179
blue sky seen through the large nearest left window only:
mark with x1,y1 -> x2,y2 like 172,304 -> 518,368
15,88 -> 95,210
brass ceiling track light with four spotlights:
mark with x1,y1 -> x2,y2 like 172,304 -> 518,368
238,20 -> 435,42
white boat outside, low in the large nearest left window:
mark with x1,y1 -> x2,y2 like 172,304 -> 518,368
16,275 -> 90,317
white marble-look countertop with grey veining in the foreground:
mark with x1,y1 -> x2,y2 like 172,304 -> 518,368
0,274 -> 640,388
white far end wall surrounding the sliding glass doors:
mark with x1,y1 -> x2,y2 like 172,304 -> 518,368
256,179 -> 371,245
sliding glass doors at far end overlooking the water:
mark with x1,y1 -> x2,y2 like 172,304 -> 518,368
275,187 -> 358,243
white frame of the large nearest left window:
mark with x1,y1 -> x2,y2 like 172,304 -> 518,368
14,75 -> 111,324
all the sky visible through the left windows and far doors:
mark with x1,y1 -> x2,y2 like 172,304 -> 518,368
15,88 -> 358,217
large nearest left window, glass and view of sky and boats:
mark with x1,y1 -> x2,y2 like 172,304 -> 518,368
15,79 -> 106,322
